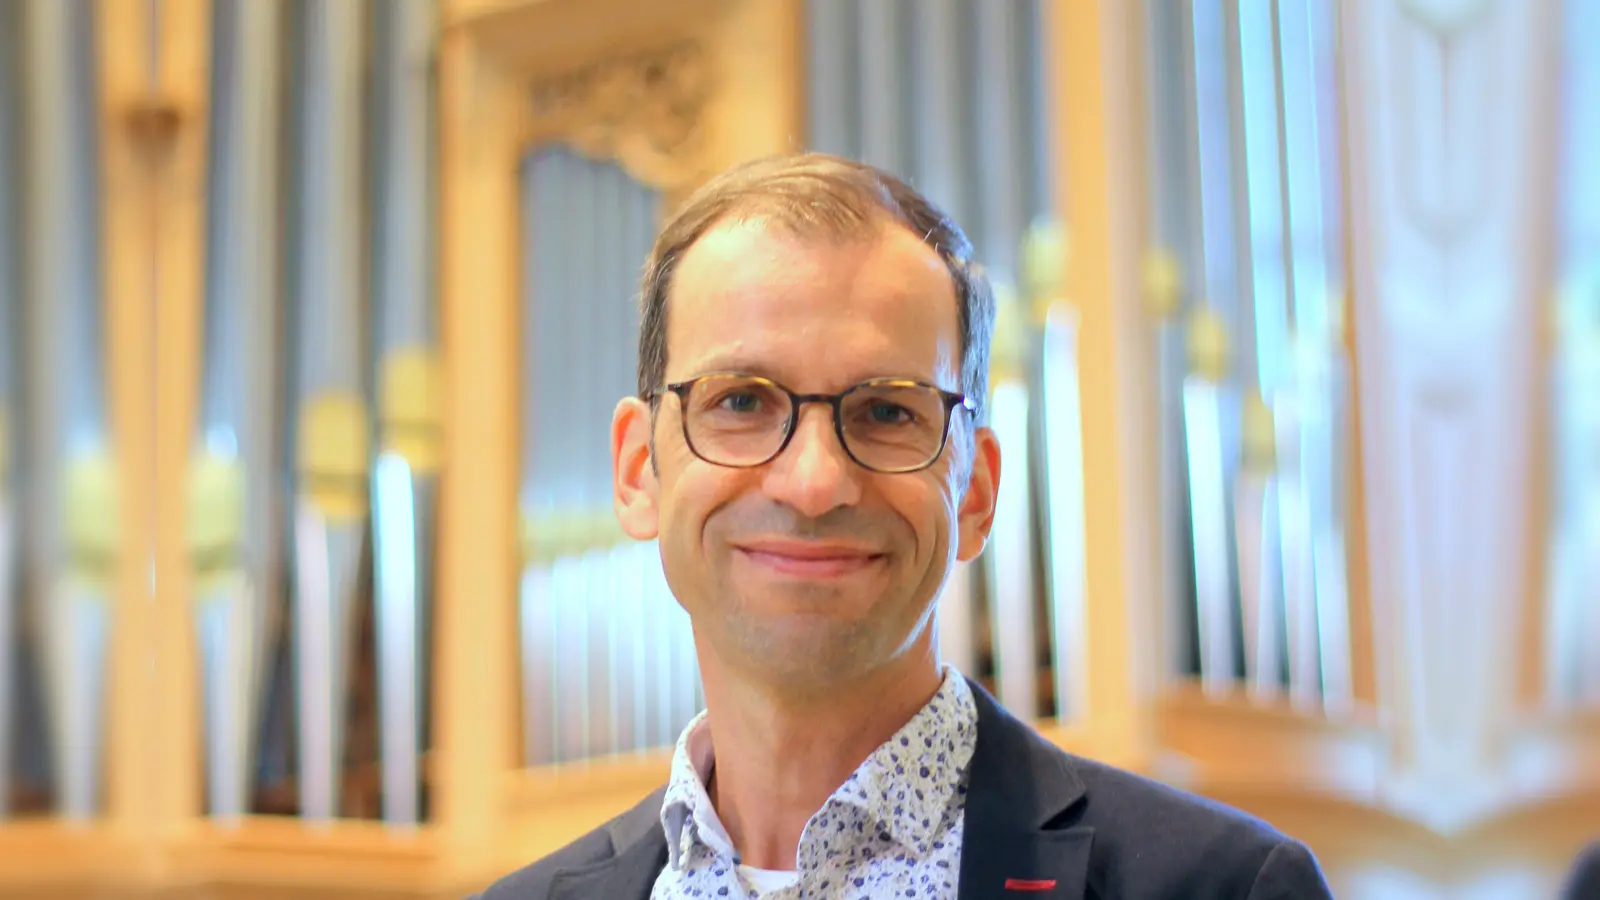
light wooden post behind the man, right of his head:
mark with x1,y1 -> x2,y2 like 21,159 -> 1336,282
1045,0 -> 1162,769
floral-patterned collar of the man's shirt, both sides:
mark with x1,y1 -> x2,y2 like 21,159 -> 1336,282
661,666 -> 978,870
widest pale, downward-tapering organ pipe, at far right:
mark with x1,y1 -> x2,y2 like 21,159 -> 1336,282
1339,0 -> 1557,826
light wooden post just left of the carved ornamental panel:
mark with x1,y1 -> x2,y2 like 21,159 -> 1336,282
432,6 -> 520,878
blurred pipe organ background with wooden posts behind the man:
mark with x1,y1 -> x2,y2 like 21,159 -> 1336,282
0,0 -> 1600,898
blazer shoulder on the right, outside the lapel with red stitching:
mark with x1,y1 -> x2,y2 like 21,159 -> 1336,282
1069,756 -> 1331,900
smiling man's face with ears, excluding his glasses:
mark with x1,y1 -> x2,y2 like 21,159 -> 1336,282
613,221 -> 998,689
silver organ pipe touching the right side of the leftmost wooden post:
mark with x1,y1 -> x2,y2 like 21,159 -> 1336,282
189,0 -> 282,820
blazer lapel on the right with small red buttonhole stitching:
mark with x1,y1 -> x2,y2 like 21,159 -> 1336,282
957,682 -> 1094,900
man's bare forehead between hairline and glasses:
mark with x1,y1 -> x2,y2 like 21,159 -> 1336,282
667,219 -> 962,389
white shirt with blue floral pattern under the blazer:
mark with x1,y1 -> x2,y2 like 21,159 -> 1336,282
650,668 -> 978,900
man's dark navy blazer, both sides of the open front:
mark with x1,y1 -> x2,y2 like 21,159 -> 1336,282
477,684 -> 1333,900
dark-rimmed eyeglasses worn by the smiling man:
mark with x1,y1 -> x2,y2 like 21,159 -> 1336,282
651,373 -> 974,474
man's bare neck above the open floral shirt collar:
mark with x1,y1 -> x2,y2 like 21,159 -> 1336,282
701,637 -> 942,870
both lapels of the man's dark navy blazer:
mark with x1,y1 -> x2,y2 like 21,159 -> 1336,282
550,679 -> 1094,900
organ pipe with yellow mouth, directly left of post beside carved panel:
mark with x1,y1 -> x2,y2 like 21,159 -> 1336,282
371,0 -> 442,828
